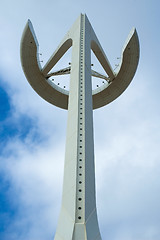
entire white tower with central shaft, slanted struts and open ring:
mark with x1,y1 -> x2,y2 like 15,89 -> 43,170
21,14 -> 139,240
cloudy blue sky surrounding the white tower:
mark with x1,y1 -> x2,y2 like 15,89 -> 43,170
0,0 -> 160,240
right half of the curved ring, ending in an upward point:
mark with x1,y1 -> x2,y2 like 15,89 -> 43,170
92,29 -> 139,109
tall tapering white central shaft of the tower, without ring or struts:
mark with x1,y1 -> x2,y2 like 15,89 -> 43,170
55,15 -> 101,240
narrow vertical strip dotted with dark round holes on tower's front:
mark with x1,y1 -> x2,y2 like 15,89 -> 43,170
76,15 -> 85,223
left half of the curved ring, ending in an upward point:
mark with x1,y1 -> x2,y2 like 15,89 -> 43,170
21,20 -> 70,109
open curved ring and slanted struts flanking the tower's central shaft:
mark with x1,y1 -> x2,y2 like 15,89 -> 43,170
21,14 -> 139,109
